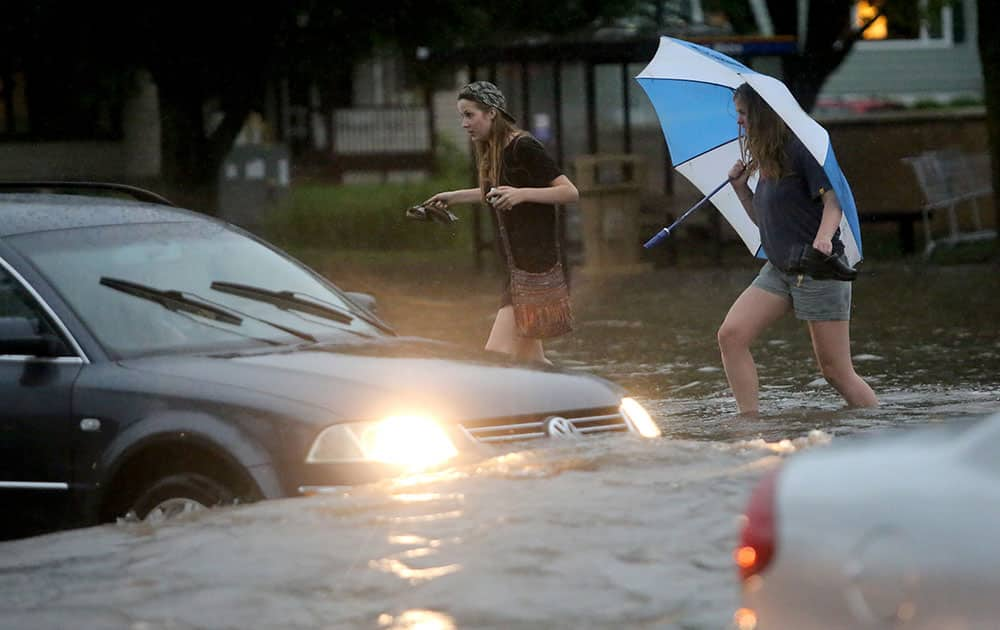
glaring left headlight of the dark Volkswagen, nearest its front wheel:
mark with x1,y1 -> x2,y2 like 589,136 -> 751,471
306,415 -> 458,469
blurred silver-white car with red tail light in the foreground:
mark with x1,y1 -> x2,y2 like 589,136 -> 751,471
735,414 -> 1000,630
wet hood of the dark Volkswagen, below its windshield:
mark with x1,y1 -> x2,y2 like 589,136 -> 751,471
121,338 -> 622,428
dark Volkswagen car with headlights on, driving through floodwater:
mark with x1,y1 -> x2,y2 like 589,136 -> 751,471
0,185 -> 659,537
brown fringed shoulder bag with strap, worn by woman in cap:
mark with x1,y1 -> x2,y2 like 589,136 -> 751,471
497,211 -> 573,339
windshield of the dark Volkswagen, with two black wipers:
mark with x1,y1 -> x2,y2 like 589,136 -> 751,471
10,221 -> 386,358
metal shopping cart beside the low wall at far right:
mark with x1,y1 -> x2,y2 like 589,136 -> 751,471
903,149 -> 997,257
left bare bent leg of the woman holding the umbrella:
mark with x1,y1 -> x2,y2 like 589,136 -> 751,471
718,286 -> 791,414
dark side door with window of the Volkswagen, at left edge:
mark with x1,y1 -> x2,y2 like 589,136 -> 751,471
0,260 -> 84,538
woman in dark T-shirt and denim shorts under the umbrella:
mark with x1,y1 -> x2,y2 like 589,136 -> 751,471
718,83 -> 878,415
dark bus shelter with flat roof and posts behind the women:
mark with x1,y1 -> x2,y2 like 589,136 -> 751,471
428,34 -> 797,267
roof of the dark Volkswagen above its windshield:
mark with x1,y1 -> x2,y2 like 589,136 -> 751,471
0,192 -> 211,237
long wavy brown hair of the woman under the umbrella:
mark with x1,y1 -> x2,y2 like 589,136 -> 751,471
733,83 -> 788,178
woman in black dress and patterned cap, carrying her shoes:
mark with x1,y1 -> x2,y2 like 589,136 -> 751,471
425,81 -> 580,362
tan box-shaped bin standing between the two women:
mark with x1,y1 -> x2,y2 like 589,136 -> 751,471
573,154 -> 649,272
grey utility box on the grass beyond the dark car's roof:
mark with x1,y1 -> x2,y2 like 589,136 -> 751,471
219,144 -> 291,232
